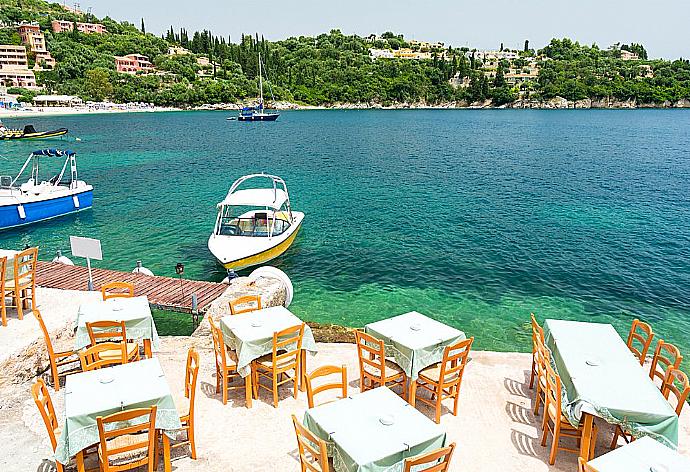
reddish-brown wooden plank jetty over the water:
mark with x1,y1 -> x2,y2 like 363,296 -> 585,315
36,261 -> 228,313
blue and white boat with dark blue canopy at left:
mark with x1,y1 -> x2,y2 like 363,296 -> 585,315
0,149 -> 93,230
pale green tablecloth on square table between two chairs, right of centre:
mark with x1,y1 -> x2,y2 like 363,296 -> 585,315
364,311 -> 465,380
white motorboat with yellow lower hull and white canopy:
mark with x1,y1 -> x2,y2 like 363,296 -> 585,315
208,174 -> 304,271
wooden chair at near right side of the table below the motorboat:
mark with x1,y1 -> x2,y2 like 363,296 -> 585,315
252,323 -> 304,408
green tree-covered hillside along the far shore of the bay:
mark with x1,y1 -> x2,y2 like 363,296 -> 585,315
0,0 -> 690,106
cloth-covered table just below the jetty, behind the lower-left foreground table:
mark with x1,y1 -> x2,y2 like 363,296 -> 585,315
74,296 -> 160,357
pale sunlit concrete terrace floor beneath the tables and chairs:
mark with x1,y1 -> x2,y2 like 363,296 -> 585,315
0,289 -> 690,472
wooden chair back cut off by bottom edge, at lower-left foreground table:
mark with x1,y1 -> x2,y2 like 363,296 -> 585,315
96,406 -> 157,472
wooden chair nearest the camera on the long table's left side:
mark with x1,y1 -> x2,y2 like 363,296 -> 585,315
541,365 -> 598,465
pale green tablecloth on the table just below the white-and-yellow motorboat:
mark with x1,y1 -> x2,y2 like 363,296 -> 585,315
220,306 -> 317,377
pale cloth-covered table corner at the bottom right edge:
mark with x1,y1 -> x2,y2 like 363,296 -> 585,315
589,437 -> 690,472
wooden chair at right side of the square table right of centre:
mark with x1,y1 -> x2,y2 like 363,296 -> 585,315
410,337 -> 474,423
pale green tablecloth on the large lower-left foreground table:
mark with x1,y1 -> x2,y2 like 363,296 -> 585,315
55,358 -> 182,464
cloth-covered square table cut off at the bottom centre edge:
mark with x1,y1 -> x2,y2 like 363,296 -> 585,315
304,387 -> 446,472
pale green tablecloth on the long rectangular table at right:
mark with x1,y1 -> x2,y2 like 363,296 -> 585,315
544,320 -> 678,449
